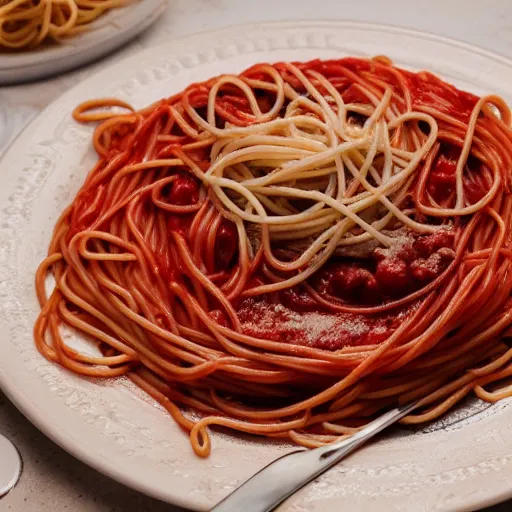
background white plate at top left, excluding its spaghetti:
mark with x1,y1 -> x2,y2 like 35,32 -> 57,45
0,0 -> 167,85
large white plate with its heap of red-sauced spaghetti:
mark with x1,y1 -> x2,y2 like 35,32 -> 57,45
0,22 -> 512,511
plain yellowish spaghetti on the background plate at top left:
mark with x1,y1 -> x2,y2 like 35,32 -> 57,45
0,0 -> 130,50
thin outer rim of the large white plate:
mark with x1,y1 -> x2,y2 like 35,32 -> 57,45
0,20 -> 512,511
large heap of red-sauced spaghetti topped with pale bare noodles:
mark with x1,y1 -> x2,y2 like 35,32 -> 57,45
34,57 -> 512,456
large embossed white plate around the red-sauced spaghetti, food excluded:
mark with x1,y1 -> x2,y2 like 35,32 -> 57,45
0,22 -> 512,512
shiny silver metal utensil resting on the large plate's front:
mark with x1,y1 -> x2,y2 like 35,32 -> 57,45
211,402 -> 419,512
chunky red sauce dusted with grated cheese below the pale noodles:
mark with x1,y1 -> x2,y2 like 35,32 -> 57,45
234,230 -> 455,350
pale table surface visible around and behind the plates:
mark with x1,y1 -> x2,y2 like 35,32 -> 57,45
0,0 -> 512,512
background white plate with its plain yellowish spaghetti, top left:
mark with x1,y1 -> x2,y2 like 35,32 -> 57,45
0,0 -> 166,85
